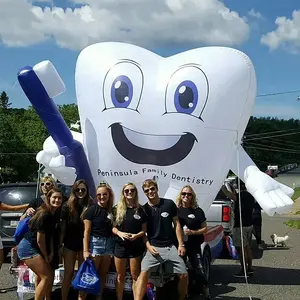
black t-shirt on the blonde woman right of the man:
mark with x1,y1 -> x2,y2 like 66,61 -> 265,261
178,207 -> 206,247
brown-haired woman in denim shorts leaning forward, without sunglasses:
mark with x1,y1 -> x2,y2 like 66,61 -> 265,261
17,188 -> 63,300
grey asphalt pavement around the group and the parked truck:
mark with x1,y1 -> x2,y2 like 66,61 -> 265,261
0,215 -> 300,300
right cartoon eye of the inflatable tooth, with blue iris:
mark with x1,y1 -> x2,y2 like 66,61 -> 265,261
166,66 -> 208,119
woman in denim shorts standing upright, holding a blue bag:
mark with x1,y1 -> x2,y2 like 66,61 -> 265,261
82,182 -> 114,299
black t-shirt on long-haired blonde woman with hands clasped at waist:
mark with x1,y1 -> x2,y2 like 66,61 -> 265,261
116,207 -> 147,247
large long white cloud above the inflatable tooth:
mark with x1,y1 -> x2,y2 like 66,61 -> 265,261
0,0 -> 249,50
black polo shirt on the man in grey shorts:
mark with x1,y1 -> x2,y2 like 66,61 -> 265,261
144,198 -> 178,247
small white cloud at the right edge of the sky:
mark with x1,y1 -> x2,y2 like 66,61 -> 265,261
260,10 -> 300,52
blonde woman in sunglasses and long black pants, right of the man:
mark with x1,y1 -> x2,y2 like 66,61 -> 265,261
176,185 -> 211,299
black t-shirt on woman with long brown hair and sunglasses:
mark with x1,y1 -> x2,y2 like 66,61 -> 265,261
61,203 -> 84,250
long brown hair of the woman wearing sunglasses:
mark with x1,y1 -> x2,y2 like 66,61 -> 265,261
67,179 -> 91,223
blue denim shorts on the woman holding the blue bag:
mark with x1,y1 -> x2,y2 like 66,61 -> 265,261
90,235 -> 115,257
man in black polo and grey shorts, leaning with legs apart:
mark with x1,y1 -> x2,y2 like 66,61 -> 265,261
135,179 -> 188,300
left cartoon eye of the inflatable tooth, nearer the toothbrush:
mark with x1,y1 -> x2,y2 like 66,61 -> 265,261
103,61 -> 144,111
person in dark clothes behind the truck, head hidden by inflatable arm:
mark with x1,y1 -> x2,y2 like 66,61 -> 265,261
222,181 -> 255,277
